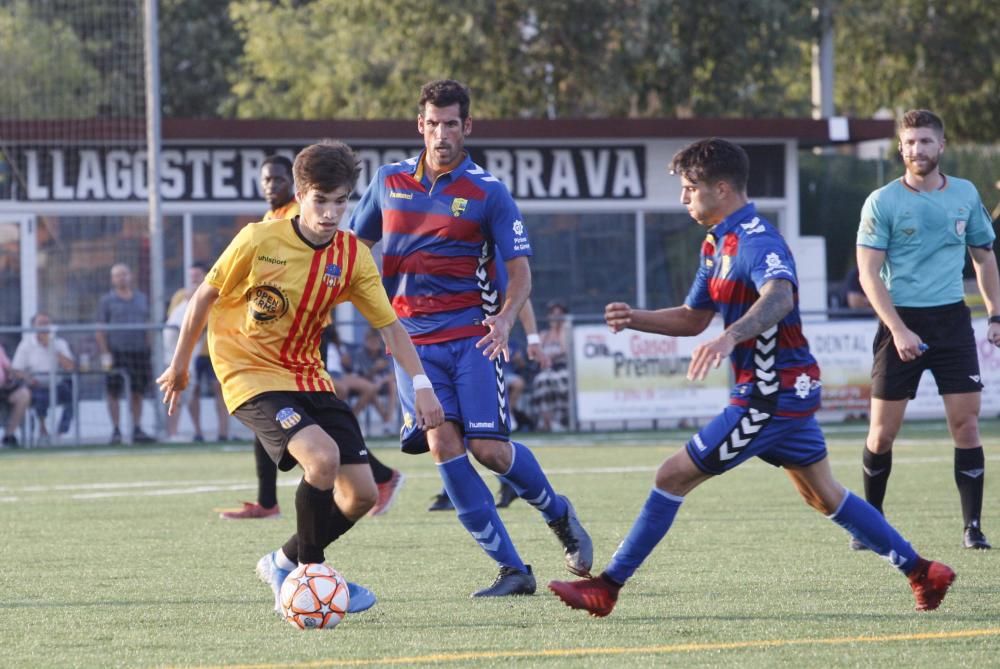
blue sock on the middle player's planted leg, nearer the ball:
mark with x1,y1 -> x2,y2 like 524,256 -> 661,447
438,453 -> 527,571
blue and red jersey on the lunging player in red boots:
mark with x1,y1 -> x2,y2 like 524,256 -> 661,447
685,202 -> 822,416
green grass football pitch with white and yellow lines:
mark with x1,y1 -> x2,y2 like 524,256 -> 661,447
0,422 -> 1000,669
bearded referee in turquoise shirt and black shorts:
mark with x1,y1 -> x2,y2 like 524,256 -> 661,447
851,109 -> 1000,550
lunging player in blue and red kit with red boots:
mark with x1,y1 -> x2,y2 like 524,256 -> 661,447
549,139 -> 955,616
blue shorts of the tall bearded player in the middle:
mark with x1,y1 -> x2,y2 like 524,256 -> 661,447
394,337 -> 510,453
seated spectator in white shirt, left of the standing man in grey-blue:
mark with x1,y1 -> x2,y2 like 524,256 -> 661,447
11,313 -> 76,444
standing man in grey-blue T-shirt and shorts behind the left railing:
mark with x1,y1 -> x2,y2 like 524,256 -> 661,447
96,263 -> 156,444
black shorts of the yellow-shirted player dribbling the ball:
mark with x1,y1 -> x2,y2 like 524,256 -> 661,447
233,390 -> 368,472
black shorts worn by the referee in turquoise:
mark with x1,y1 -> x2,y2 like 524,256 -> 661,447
872,302 -> 983,401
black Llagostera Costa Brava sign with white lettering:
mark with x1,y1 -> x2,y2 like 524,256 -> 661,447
0,144 -> 646,202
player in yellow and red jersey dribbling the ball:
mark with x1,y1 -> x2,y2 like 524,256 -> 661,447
157,142 -> 444,612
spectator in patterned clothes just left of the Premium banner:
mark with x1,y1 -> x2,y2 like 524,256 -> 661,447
531,300 -> 570,432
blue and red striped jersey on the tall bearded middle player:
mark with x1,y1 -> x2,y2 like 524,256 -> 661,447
349,154 -> 531,344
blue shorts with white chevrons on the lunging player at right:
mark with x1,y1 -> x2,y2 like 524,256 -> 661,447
687,404 -> 826,475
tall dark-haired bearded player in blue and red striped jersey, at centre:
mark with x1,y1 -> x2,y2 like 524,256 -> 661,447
350,80 -> 593,597
